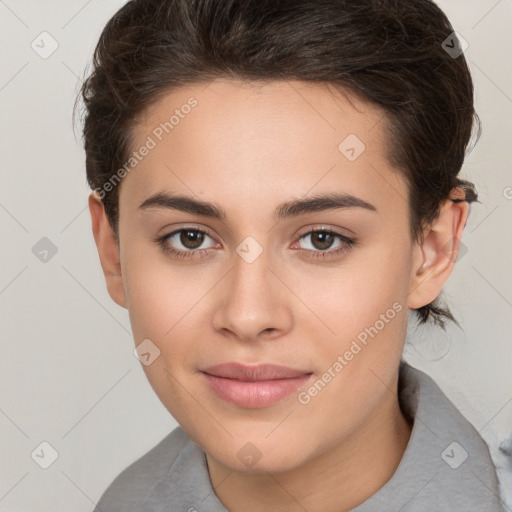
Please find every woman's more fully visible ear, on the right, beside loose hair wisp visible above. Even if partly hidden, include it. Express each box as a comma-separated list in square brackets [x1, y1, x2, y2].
[407, 187, 469, 309]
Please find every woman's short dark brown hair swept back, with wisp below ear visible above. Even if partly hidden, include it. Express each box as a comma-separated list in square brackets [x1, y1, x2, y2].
[75, 0, 480, 328]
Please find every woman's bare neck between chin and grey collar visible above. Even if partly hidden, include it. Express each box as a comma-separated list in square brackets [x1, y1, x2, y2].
[206, 380, 412, 512]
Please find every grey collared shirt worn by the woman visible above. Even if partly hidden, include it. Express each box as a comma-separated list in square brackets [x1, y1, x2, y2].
[94, 361, 504, 512]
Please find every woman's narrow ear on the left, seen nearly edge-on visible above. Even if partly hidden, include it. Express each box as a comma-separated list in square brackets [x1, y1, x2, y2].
[89, 192, 126, 308]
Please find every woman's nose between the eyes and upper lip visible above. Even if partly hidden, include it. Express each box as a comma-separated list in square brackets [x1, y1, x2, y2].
[213, 244, 293, 342]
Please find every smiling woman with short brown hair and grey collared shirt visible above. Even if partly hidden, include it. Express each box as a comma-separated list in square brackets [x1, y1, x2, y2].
[78, 0, 503, 512]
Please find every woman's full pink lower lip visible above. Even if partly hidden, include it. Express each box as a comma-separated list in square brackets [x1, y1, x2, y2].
[199, 373, 313, 408]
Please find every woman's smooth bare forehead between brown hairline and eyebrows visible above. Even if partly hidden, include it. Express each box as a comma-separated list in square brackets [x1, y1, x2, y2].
[121, 79, 407, 222]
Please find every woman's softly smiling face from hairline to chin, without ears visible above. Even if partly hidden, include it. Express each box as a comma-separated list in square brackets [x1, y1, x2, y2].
[92, 80, 424, 471]
